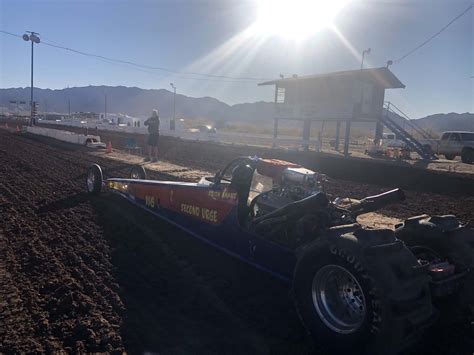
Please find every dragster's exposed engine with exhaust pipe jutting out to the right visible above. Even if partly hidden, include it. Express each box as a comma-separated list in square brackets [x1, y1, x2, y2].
[249, 163, 404, 248]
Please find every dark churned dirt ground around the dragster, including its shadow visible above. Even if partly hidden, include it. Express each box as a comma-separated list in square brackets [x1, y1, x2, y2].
[0, 130, 474, 354]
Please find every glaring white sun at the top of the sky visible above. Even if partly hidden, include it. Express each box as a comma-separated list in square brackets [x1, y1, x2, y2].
[253, 0, 350, 40]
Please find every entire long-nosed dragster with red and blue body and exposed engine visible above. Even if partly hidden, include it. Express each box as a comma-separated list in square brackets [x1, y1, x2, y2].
[87, 157, 474, 354]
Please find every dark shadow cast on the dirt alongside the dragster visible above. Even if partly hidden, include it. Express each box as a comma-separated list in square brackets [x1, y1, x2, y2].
[91, 196, 320, 354]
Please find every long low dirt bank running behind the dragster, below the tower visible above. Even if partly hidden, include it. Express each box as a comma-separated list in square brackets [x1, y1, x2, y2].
[41, 124, 474, 196]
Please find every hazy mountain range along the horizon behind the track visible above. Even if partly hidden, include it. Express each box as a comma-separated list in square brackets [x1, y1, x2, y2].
[0, 86, 474, 133]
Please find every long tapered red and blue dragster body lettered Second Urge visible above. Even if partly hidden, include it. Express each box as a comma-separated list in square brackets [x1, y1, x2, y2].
[106, 178, 296, 282]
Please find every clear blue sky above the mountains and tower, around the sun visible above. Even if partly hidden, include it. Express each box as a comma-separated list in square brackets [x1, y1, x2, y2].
[0, 0, 474, 118]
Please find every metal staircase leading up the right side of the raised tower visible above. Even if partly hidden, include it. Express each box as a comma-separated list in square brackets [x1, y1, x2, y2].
[381, 102, 437, 160]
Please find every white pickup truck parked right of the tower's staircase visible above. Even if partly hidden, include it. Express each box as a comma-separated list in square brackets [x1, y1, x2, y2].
[421, 131, 474, 164]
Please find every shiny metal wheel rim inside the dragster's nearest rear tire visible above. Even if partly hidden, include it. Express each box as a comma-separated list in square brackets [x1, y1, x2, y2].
[311, 264, 367, 334]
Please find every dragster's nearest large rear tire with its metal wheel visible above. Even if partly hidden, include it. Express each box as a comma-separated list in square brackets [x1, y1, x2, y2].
[293, 229, 432, 354]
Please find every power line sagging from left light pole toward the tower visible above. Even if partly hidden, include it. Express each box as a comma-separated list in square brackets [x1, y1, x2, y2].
[0, 30, 270, 82]
